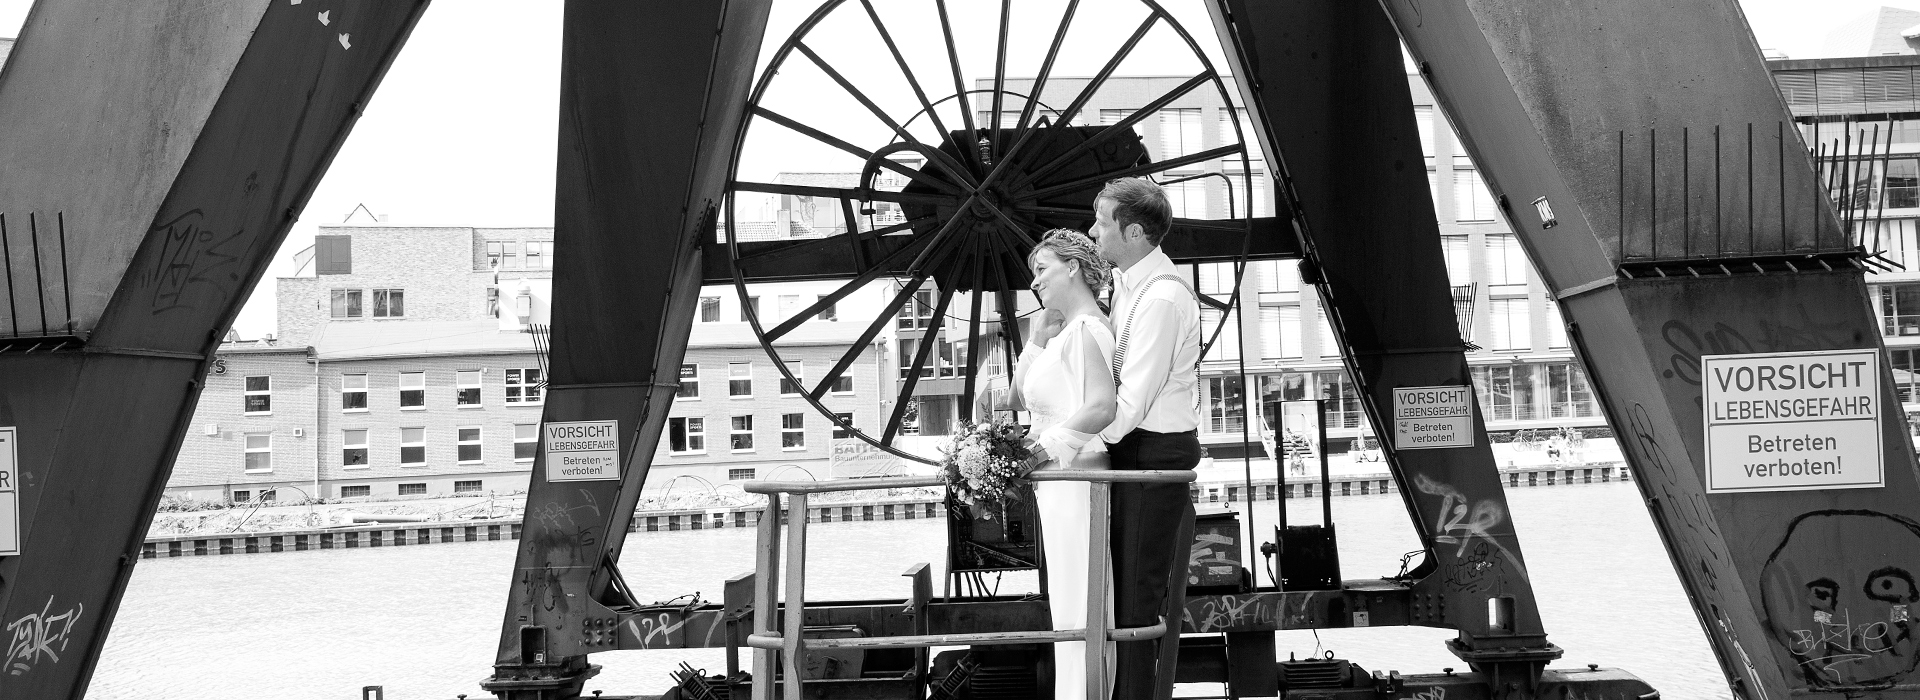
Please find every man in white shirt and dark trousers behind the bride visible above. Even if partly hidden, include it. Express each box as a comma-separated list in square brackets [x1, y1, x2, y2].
[1092, 178, 1200, 700]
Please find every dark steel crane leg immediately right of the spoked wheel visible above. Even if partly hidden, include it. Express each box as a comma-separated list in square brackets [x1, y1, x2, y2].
[1208, 0, 1559, 687]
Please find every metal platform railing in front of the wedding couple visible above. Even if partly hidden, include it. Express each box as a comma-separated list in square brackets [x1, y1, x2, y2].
[743, 470, 1194, 700]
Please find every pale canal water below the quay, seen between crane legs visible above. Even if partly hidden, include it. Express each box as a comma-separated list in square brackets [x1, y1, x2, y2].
[88, 481, 1730, 700]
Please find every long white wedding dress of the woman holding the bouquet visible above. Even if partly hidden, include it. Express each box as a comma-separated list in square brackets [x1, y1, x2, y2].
[1020, 316, 1114, 700]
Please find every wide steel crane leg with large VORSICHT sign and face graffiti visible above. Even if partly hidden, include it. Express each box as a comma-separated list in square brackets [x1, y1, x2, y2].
[1382, 0, 1920, 700]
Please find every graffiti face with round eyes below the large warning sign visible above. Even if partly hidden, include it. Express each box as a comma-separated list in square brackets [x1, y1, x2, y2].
[1761, 510, 1920, 690]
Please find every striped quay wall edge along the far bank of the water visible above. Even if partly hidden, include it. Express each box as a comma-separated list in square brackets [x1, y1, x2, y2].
[140, 462, 1628, 558]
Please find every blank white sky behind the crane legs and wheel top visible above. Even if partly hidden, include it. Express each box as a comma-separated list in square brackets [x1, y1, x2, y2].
[0, 0, 1920, 338]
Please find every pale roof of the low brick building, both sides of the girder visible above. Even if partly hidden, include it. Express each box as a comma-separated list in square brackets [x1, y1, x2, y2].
[307, 320, 864, 361]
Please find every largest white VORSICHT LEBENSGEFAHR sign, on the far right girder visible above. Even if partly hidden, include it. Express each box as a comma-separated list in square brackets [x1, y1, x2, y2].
[1699, 349, 1885, 493]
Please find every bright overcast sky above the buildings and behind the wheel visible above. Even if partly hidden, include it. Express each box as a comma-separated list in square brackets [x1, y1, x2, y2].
[0, 0, 1920, 338]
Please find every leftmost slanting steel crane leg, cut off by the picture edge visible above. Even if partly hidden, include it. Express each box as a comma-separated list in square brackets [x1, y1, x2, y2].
[0, 0, 426, 698]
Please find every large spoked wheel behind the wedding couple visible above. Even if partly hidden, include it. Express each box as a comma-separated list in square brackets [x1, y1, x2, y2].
[720, 0, 1256, 462]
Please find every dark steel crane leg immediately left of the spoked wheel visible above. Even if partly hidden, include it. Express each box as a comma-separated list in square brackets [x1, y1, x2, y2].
[484, 0, 770, 700]
